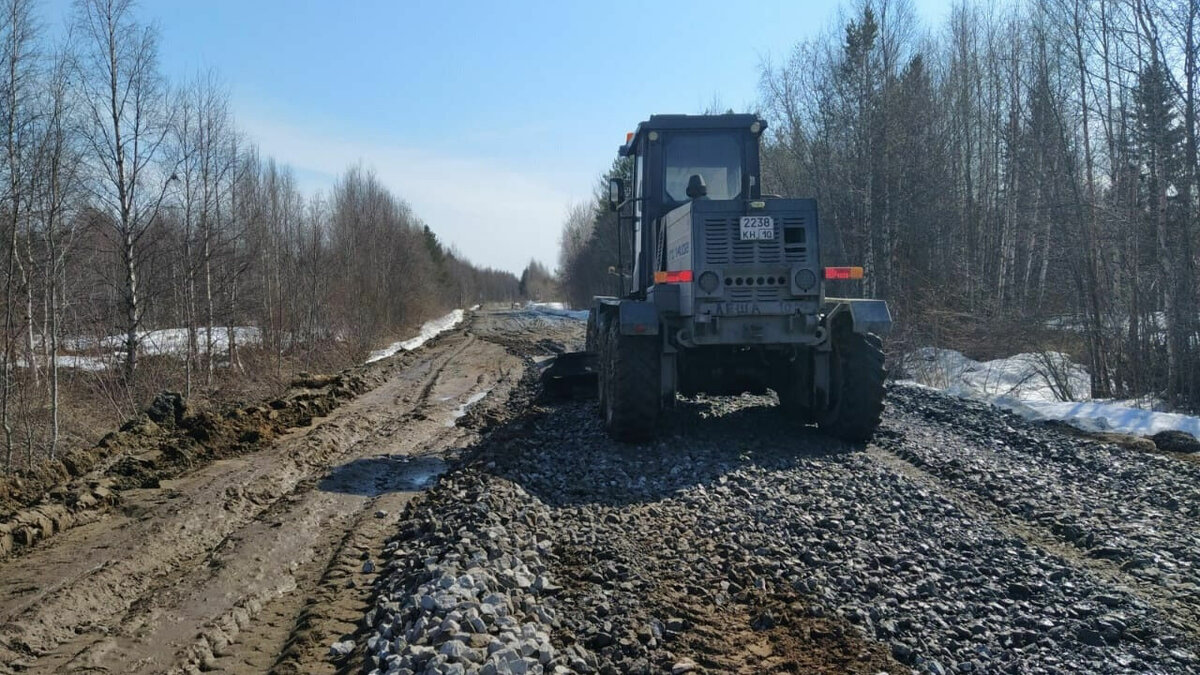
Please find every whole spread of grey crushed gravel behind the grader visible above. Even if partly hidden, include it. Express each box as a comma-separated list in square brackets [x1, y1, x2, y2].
[358, 388, 1200, 673]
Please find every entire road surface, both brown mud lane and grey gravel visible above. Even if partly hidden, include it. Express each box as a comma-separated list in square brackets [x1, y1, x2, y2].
[0, 311, 1200, 674]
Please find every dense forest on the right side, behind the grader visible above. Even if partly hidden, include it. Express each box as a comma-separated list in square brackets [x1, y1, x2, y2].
[559, 0, 1200, 411]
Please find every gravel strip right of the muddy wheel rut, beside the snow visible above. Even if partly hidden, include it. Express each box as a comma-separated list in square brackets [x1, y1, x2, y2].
[882, 389, 1200, 629]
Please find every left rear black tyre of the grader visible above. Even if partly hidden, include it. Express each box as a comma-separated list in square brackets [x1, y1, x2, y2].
[600, 321, 662, 443]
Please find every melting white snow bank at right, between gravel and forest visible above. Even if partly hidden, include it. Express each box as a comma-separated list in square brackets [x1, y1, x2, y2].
[901, 347, 1200, 438]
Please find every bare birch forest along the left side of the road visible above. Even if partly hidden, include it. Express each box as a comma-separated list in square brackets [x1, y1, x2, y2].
[0, 0, 520, 470]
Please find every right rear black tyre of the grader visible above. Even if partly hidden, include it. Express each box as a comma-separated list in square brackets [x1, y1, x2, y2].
[817, 330, 888, 443]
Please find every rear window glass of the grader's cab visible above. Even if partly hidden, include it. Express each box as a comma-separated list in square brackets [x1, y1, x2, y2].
[665, 133, 742, 202]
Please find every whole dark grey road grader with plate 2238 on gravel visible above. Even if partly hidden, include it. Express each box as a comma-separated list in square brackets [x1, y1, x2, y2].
[549, 114, 892, 441]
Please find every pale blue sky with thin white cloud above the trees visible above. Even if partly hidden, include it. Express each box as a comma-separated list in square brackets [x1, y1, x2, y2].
[43, 0, 946, 271]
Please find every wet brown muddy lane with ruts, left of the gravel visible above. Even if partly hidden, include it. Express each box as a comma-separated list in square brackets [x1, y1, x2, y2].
[0, 307, 572, 673]
